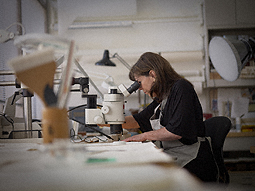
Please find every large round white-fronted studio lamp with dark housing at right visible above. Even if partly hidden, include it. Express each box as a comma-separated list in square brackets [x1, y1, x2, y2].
[209, 36, 255, 81]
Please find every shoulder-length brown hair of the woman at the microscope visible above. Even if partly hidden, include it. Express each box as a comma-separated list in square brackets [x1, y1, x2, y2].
[129, 52, 186, 101]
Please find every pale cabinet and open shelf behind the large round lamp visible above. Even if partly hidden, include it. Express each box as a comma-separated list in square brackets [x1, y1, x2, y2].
[204, 0, 255, 87]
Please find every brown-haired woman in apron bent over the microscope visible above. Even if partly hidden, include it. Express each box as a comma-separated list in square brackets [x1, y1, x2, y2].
[123, 52, 217, 181]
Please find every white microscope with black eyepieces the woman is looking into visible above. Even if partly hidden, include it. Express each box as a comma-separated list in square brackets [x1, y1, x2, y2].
[74, 77, 140, 139]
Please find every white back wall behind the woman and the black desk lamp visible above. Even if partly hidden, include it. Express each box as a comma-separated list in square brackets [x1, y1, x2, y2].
[55, 0, 205, 112]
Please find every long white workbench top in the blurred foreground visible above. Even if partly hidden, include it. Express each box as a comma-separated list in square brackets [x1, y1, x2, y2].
[0, 139, 204, 191]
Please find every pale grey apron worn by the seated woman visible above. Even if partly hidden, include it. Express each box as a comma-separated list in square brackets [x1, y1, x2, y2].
[150, 99, 202, 167]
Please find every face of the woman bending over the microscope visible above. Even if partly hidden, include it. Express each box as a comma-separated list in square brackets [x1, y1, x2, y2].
[135, 72, 155, 95]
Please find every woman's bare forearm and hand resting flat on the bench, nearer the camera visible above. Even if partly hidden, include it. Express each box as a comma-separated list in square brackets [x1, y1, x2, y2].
[123, 127, 182, 142]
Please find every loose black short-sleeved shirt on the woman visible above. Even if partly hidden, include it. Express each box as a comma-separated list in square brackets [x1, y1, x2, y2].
[133, 79, 205, 144]
